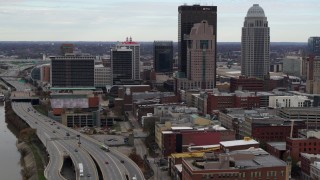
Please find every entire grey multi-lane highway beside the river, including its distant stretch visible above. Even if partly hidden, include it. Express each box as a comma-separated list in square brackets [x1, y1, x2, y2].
[3, 64, 144, 180]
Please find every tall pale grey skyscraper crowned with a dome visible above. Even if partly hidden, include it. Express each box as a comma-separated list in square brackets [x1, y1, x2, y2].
[241, 4, 270, 78]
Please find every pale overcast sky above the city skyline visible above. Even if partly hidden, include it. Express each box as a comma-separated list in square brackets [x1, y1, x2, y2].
[0, 0, 320, 42]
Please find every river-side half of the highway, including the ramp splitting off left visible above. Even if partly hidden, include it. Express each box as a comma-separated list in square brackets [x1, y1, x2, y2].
[12, 102, 99, 180]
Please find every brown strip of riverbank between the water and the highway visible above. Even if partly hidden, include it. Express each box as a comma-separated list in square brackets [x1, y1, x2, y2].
[5, 102, 49, 180]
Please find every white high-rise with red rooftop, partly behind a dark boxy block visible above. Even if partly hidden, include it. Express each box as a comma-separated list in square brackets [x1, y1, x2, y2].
[116, 37, 140, 80]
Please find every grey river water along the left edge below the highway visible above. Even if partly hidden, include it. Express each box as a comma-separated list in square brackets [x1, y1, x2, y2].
[0, 102, 22, 180]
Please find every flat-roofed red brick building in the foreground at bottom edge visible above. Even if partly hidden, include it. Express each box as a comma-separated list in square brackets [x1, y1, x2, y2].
[182, 148, 289, 180]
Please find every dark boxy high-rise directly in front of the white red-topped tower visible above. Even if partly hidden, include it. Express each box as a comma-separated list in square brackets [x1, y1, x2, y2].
[111, 47, 134, 84]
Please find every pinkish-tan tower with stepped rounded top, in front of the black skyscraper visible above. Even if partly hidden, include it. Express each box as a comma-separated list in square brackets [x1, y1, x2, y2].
[177, 20, 216, 90]
